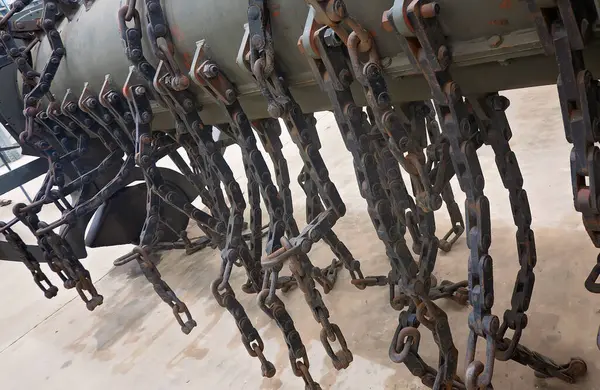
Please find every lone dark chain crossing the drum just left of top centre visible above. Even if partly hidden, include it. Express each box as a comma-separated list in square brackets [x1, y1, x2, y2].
[244, 0, 383, 291]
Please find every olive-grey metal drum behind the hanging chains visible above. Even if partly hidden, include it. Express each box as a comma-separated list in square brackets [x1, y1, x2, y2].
[35, 0, 598, 129]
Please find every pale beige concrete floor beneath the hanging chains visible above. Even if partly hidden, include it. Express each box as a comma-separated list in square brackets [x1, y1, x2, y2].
[0, 86, 600, 390]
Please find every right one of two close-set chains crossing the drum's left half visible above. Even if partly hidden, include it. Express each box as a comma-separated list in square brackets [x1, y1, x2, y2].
[119, 1, 290, 376]
